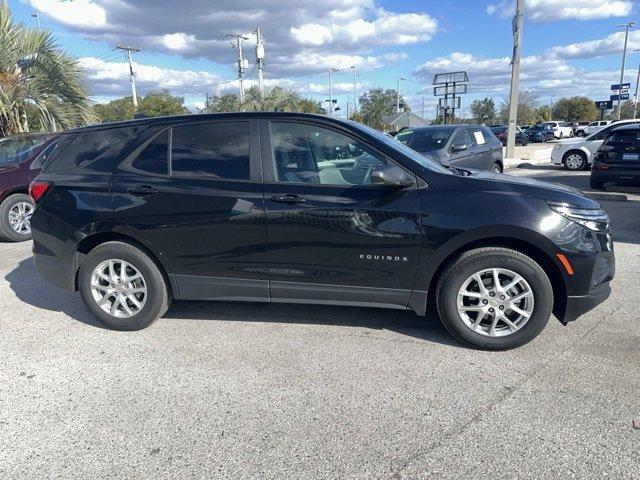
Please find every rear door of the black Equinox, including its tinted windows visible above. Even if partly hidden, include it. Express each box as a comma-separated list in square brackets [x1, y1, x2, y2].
[111, 120, 268, 301]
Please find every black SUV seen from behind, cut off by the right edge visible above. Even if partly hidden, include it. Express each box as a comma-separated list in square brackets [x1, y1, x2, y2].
[590, 124, 640, 190]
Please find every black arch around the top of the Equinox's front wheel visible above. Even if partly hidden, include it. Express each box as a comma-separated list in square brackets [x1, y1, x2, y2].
[427, 235, 567, 323]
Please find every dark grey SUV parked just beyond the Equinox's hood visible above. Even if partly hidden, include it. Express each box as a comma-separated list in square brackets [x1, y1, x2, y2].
[396, 125, 504, 173]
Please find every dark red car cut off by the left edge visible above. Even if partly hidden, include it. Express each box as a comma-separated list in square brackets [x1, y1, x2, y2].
[0, 133, 58, 242]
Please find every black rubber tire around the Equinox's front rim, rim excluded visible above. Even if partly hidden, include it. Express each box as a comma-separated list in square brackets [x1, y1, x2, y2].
[435, 247, 553, 350]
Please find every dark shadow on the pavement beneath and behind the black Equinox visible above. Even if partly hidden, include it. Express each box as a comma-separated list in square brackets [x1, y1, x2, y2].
[5, 258, 461, 347]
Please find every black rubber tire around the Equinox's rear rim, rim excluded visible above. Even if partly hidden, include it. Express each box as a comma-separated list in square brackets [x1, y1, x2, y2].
[78, 242, 171, 330]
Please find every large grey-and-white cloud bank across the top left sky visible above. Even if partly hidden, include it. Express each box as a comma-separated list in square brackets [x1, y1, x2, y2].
[23, 0, 437, 76]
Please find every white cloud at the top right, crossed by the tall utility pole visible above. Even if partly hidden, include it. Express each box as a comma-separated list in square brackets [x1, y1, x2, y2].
[487, 0, 633, 23]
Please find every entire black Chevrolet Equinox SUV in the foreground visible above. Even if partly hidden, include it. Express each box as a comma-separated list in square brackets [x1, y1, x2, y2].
[30, 113, 614, 349]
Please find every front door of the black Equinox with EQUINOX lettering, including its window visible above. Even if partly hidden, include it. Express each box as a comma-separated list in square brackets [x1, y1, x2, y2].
[261, 120, 420, 308]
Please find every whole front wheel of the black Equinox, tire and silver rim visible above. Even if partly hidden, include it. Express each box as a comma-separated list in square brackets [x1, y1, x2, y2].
[435, 247, 553, 350]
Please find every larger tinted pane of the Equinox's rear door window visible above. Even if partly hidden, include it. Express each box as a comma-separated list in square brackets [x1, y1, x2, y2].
[171, 122, 251, 180]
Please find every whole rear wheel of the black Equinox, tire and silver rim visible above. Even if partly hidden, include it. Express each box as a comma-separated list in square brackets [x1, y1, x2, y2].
[78, 242, 171, 330]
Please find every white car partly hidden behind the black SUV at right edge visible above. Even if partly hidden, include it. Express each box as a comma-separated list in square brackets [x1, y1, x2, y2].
[551, 119, 640, 170]
